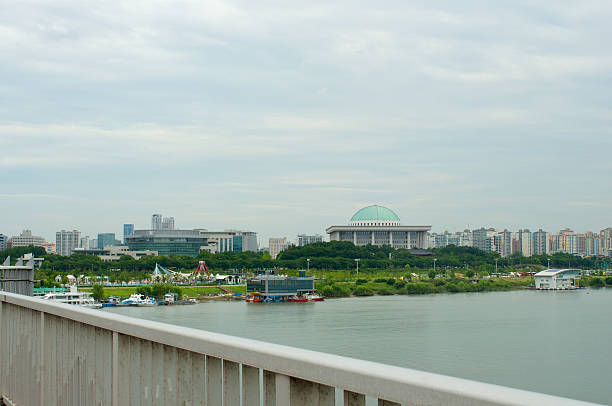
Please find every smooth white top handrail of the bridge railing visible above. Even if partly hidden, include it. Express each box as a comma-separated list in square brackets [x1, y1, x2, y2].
[0, 292, 594, 406]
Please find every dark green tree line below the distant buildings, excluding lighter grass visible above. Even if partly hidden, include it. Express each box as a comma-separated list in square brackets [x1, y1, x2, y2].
[0, 241, 612, 278]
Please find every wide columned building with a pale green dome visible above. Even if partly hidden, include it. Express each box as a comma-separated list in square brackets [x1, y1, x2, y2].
[325, 205, 431, 249]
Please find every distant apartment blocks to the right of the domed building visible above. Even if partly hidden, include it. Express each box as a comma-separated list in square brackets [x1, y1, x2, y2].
[428, 227, 612, 257]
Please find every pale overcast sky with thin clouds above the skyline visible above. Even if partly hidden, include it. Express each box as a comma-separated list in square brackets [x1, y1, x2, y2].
[0, 0, 612, 246]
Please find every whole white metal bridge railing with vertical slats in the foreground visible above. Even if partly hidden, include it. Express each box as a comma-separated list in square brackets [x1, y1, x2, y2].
[0, 292, 604, 406]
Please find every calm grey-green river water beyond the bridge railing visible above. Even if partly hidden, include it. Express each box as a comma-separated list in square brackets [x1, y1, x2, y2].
[107, 289, 612, 404]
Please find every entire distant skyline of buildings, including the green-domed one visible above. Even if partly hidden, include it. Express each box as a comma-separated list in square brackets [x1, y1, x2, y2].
[0, 205, 612, 261]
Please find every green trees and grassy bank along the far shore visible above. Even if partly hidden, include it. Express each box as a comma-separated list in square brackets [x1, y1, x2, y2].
[0, 241, 612, 297]
